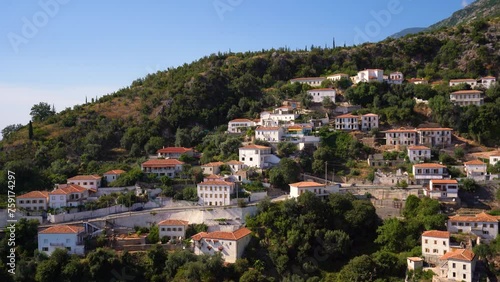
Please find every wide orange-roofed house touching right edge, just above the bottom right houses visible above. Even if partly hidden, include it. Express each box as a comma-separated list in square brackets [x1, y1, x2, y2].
[447, 212, 499, 241]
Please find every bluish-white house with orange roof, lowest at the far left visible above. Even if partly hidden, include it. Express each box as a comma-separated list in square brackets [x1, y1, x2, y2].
[38, 225, 85, 255]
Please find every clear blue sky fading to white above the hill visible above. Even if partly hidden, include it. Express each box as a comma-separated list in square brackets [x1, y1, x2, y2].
[0, 0, 471, 137]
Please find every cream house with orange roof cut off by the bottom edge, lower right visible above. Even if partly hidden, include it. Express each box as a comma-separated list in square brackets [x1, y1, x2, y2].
[438, 249, 477, 282]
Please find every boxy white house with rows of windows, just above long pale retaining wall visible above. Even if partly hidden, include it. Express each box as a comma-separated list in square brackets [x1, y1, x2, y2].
[197, 177, 235, 206]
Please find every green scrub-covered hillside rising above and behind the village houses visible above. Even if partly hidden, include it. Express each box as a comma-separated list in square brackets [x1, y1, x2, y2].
[0, 19, 500, 192]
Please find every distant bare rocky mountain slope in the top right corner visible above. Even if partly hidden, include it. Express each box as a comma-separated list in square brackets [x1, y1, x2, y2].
[429, 0, 500, 30]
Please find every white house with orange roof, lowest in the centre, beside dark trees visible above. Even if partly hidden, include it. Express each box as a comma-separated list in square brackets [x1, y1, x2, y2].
[191, 227, 252, 263]
